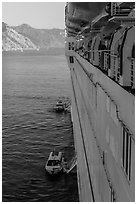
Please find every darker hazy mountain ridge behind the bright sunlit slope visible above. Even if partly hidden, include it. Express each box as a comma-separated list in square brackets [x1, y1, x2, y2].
[13, 24, 65, 49]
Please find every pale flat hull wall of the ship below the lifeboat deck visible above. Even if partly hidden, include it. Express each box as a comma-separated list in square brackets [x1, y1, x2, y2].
[66, 50, 135, 202]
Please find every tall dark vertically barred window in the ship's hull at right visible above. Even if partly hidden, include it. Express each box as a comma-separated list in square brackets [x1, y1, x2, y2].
[122, 126, 132, 181]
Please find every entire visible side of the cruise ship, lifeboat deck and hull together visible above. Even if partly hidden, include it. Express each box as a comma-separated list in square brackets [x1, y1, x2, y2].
[65, 2, 135, 202]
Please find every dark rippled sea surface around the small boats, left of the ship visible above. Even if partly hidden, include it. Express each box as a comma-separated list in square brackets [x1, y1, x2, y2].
[2, 54, 78, 202]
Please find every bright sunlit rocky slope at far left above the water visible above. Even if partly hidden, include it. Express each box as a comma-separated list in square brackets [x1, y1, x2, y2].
[2, 23, 38, 51]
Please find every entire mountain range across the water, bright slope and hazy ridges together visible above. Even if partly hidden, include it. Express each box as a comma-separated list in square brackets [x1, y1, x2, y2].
[2, 22, 65, 51]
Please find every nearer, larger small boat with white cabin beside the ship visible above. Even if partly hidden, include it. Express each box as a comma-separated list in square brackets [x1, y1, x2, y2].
[45, 151, 64, 175]
